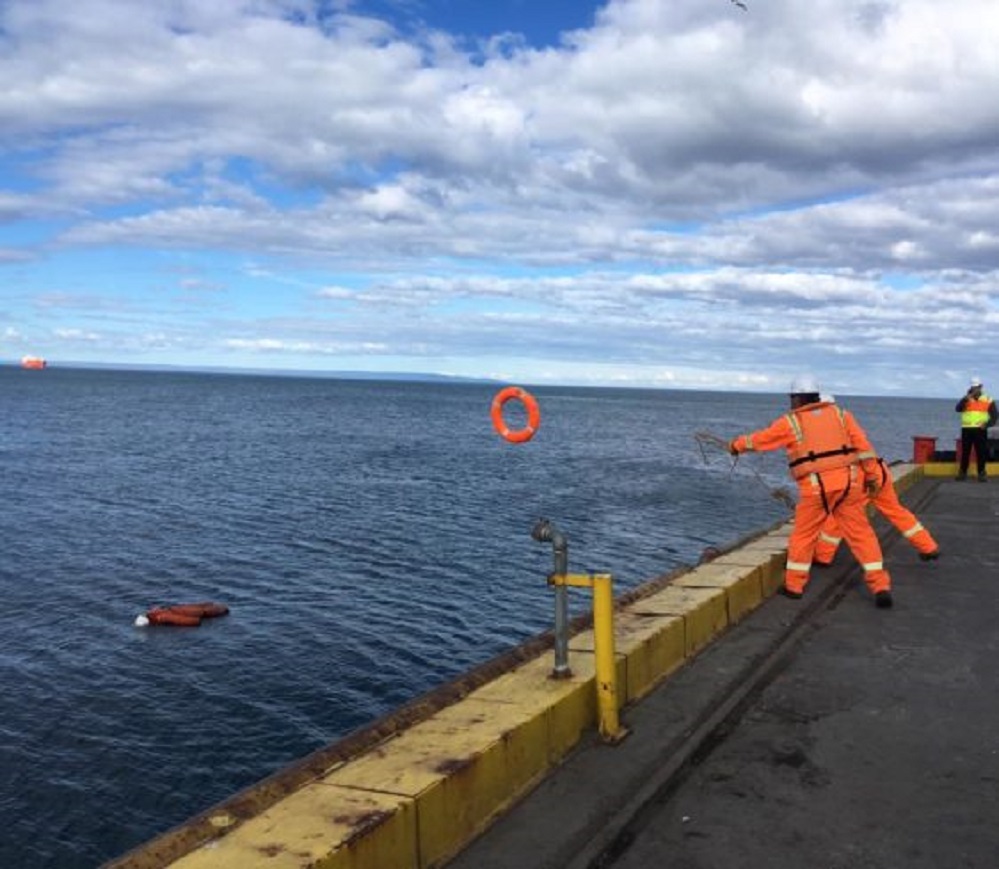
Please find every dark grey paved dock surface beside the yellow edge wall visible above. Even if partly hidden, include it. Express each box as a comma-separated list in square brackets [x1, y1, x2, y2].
[447, 478, 999, 869]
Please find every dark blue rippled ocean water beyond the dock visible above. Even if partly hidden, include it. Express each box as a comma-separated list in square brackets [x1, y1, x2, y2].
[0, 366, 957, 869]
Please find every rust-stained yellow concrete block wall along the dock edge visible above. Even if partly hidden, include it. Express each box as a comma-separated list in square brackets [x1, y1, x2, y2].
[107, 463, 925, 869]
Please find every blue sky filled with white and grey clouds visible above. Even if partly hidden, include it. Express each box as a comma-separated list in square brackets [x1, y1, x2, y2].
[0, 0, 999, 397]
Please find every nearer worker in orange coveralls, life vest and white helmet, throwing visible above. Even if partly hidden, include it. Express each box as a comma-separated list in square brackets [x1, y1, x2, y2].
[729, 375, 892, 608]
